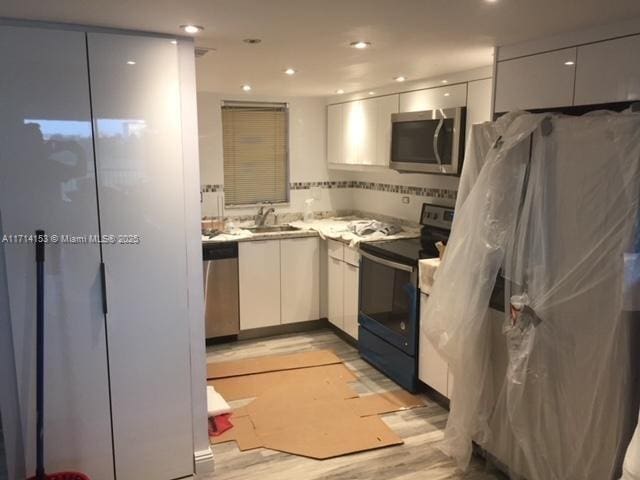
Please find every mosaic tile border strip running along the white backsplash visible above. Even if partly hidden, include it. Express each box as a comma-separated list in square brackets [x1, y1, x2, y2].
[201, 180, 458, 200]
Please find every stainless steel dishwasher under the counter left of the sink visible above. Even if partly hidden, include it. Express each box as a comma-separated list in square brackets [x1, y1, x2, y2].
[202, 242, 240, 338]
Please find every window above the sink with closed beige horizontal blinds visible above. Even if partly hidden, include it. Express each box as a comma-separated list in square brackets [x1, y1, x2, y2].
[222, 102, 289, 205]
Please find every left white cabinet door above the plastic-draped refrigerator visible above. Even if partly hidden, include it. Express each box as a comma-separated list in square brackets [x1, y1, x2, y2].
[495, 48, 576, 112]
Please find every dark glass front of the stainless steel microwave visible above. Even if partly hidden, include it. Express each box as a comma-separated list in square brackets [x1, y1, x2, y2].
[391, 118, 454, 165]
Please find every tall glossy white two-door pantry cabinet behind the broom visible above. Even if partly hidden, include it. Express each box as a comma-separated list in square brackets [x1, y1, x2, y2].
[0, 24, 206, 480]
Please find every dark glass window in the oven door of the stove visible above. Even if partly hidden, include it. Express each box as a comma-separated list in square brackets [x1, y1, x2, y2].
[360, 257, 417, 338]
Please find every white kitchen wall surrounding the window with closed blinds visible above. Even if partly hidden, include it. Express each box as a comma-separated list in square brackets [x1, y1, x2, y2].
[198, 92, 351, 216]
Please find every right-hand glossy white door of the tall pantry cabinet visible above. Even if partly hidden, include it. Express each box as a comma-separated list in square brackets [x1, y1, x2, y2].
[88, 33, 193, 479]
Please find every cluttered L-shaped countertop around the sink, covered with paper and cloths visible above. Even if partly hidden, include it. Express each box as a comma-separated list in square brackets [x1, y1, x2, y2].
[202, 217, 420, 247]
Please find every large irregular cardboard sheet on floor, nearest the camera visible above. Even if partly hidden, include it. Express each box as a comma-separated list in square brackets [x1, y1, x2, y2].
[209, 354, 424, 459]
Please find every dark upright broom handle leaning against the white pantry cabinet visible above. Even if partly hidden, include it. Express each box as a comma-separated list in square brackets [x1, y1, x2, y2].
[36, 230, 45, 480]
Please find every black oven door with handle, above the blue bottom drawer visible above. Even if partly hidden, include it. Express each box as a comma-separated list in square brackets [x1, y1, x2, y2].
[358, 251, 420, 356]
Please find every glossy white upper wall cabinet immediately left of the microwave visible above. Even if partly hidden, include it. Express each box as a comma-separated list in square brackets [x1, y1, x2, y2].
[327, 95, 398, 166]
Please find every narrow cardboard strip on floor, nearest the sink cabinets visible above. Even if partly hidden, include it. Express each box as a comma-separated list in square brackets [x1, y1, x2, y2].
[207, 350, 342, 380]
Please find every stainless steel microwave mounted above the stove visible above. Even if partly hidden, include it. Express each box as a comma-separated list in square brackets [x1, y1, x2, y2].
[390, 107, 467, 175]
